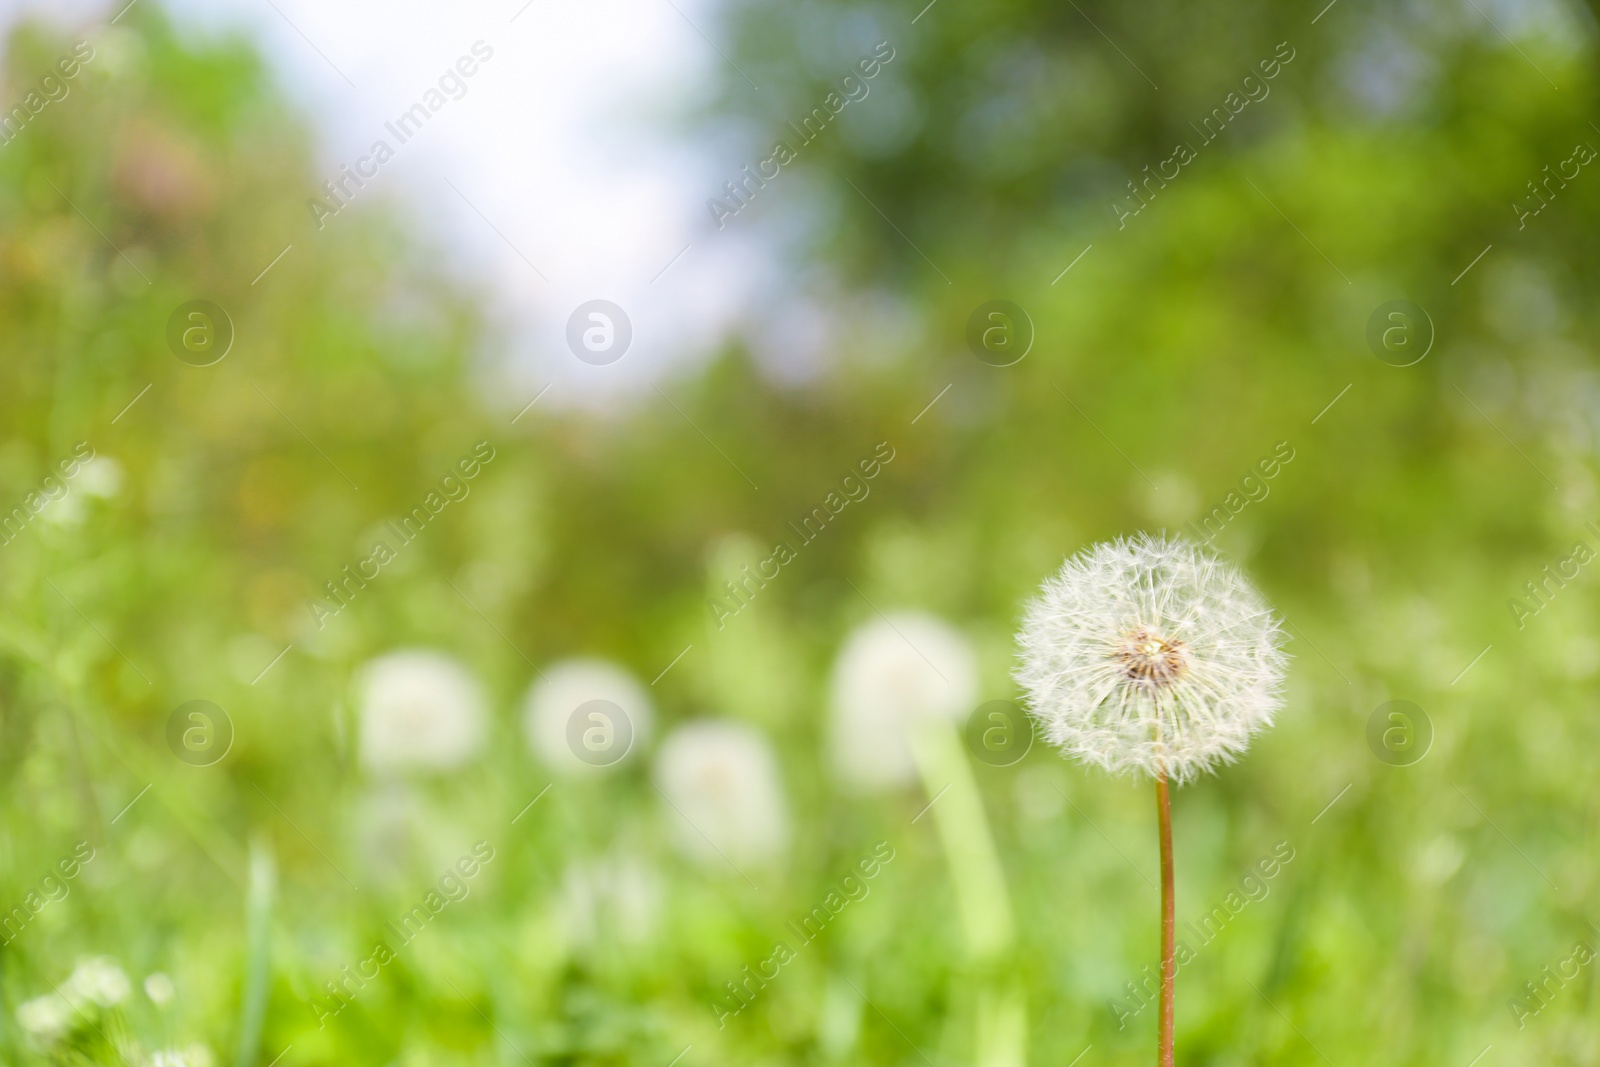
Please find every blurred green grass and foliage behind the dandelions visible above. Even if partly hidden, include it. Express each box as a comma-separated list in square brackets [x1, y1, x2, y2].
[0, 0, 1600, 1067]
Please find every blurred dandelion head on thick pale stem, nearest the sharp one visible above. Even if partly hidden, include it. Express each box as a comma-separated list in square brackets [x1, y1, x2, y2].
[830, 613, 978, 789]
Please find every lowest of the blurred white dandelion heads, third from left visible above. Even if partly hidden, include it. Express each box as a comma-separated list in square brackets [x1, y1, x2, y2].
[656, 720, 789, 867]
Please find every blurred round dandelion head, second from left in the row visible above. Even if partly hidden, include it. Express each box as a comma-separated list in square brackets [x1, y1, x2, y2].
[522, 659, 654, 774]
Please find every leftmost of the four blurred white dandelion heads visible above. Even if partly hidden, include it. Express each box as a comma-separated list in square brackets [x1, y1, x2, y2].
[360, 649, 485, 773]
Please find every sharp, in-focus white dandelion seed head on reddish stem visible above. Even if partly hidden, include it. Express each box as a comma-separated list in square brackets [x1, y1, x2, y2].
[1016, 534, 1288, 782]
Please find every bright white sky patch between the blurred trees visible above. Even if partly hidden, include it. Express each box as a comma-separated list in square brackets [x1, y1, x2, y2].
[0, 0, 771, 403]
